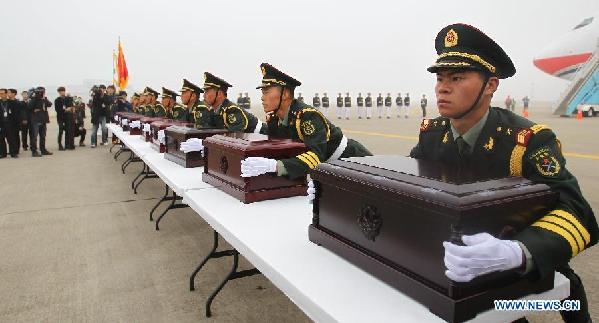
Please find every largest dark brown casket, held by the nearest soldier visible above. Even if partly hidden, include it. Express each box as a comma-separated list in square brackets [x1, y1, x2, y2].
[309, 156, 557, 322]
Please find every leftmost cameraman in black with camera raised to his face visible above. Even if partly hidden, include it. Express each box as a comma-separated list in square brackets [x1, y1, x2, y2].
[27, 86, 52, 157]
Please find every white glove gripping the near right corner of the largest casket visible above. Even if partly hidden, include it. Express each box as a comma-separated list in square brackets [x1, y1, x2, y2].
[443, 232, 522, 282]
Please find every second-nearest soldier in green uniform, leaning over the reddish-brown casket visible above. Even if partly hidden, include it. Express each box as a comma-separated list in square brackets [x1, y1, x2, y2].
[241, 63, 371, 179]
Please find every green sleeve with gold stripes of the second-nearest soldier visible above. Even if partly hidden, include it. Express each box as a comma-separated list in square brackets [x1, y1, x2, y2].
[281, 111, 330, 179]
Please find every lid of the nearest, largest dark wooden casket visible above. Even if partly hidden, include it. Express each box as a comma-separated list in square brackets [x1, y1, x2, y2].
[313, 155, 549, 207]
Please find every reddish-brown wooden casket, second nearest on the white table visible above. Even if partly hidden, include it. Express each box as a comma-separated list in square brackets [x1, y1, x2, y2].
[202, 133, 308, 203]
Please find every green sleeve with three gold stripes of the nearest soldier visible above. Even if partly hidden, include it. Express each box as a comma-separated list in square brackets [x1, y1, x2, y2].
[516, 129, 599, 277]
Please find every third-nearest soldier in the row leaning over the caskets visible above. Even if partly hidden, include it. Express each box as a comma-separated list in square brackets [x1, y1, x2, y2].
[204, 72, 262, 133]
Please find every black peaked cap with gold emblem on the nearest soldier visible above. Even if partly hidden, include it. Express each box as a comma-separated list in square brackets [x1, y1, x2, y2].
[427, 24, 516, 79]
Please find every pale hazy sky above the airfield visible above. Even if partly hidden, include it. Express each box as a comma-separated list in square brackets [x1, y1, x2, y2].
[0, 0, 599, 100]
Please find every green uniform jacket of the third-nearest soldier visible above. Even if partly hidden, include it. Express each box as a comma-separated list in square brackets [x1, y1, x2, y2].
[210, 99, 262, 132]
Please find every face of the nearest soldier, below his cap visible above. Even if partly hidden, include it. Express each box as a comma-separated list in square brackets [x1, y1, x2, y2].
[436, 70, 497, 118]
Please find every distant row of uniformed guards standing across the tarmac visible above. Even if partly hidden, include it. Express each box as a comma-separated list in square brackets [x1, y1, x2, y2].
[290, 93, 428, 120]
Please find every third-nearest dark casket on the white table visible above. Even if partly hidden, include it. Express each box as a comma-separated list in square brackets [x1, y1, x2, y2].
[164, 126, 228, 168]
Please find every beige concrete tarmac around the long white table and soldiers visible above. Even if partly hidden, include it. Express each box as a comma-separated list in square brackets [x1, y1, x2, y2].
[0, 106, 599, 322]
